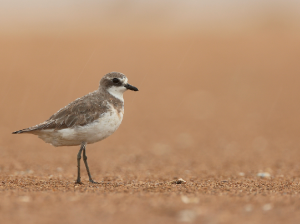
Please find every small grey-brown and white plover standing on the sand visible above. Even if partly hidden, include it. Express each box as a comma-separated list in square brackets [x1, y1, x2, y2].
[13, 72, 138, 184]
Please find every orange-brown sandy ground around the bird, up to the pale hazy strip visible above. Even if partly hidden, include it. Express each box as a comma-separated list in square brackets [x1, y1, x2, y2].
[0, 32, 300, 224]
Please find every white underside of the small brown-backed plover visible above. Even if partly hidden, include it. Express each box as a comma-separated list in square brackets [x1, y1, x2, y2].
[34, 105, 124, 146]
